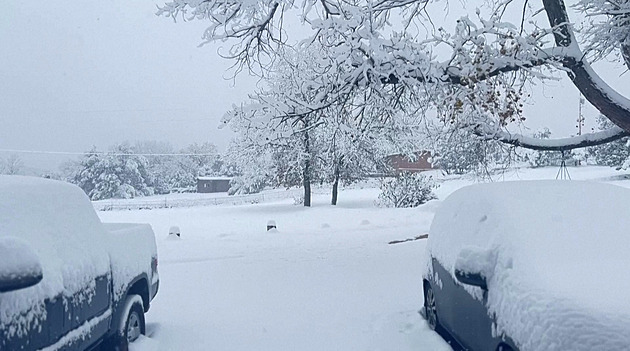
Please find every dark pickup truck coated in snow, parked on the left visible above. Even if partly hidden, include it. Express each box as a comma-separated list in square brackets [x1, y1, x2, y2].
[0, 176, 159, 351]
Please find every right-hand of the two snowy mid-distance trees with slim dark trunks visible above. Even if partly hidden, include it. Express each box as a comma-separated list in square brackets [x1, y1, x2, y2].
[319, 89, 422, 205]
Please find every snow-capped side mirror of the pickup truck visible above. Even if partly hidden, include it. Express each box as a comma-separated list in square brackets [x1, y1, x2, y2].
[0, 236, 43, 293]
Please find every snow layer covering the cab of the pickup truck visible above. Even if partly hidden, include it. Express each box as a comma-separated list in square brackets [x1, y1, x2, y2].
[0, 176, 109, 333]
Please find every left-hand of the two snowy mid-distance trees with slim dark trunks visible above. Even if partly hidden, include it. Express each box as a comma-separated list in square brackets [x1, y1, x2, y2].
[223, 46, 338, 206]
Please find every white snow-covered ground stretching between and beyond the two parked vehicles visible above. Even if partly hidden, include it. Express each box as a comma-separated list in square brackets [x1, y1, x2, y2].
[99, 167, 630, 351]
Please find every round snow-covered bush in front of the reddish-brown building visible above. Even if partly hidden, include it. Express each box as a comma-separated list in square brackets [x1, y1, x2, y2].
[376, 173, 437, 207]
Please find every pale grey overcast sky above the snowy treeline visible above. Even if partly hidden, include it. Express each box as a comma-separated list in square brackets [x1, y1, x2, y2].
[0, 0, 630, 173]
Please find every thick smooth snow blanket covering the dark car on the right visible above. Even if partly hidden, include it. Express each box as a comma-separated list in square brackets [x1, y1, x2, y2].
[427, 181, 630, 350]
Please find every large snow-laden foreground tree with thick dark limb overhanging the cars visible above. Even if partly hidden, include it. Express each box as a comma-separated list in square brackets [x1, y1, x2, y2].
[158, 0, 630, 151]
